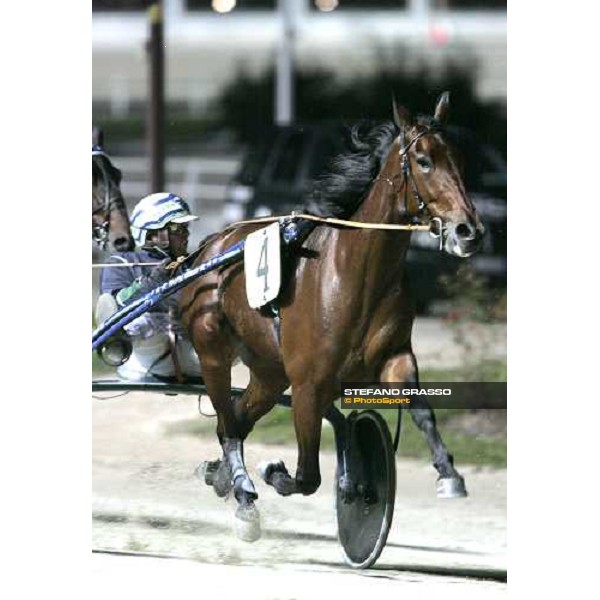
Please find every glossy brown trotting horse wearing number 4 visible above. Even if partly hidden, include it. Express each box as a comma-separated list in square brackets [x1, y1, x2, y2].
[180, 93, 484, 539]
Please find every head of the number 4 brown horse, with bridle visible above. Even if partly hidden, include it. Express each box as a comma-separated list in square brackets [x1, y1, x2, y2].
[392, 92, 485, 257]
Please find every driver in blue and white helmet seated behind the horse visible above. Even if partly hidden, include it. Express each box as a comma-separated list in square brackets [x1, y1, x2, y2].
[96, 192, 200, 381]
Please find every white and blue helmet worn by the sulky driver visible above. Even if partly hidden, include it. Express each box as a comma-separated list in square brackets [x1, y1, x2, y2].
[131, 192, 198, 246]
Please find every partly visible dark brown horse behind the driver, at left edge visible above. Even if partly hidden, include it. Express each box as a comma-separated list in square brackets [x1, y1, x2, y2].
[92, 127, 134, 252]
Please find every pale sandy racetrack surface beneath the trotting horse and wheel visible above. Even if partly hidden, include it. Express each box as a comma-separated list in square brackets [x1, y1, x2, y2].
[92, 364, 506, 599]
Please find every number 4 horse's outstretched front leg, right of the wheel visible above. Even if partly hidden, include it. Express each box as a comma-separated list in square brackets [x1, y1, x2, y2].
[380, 352, 467, 498]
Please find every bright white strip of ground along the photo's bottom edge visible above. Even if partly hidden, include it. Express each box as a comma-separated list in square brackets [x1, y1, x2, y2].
[92, 554, 506, 600]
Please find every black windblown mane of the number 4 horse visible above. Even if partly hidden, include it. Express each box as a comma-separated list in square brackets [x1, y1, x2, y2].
[306, 122, 398, 218]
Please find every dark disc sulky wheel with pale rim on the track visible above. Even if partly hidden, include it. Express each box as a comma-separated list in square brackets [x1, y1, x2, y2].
[336, 410, 396, 569]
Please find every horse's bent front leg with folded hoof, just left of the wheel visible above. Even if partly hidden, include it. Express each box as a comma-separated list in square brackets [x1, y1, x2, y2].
[259, 384, 328, 496]
